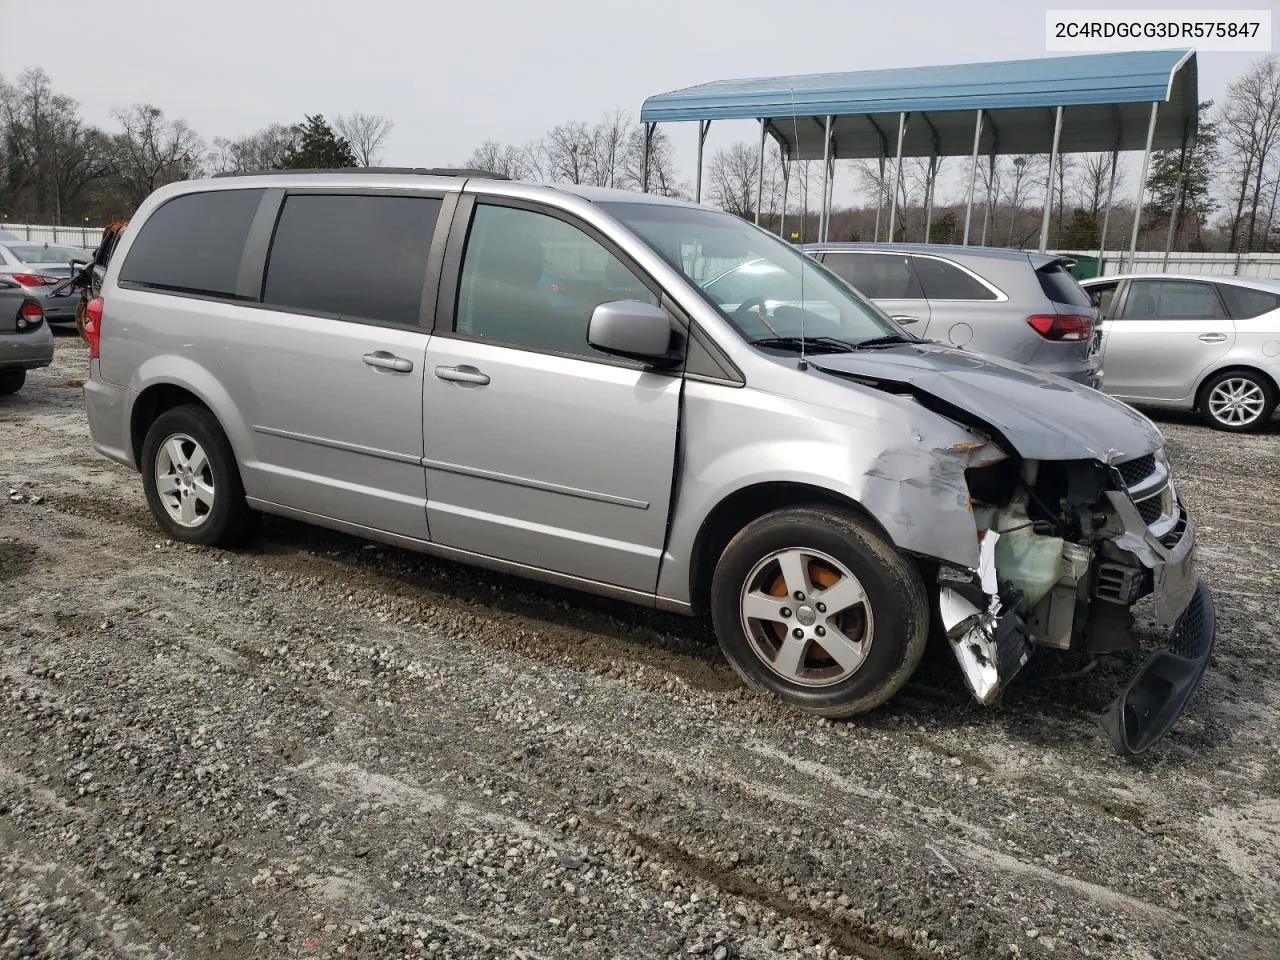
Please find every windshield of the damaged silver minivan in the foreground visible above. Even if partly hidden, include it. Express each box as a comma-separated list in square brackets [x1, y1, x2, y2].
[602, 202, 908, 348]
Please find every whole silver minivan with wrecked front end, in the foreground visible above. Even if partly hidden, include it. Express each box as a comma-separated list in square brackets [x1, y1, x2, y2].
[84, 172, 1213, 753]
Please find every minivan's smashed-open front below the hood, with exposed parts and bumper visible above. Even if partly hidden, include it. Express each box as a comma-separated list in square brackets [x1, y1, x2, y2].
[938, 448, 1213, 755]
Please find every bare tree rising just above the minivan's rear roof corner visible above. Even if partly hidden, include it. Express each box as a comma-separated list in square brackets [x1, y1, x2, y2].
[108, 104, 205, 206]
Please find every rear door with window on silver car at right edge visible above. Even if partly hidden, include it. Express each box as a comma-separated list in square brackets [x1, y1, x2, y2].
[1102, 279, 1235, 403]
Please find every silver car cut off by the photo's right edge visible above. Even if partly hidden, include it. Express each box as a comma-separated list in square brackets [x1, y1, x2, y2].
[1083, 274, 1280, 433]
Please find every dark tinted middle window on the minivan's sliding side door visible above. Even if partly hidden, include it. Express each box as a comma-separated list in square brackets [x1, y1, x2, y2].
[262, 193, 440, 326]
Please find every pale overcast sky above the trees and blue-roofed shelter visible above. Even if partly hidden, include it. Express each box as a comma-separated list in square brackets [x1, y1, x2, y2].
[0, 0, 1264, 208]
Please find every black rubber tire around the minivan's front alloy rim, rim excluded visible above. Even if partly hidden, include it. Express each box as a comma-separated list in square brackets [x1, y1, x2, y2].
[710, 506, 929, 717]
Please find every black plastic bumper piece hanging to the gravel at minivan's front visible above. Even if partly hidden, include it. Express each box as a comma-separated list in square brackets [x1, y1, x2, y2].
[1100, 582, 1217, 756]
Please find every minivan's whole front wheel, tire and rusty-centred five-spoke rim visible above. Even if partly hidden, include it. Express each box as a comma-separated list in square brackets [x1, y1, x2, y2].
[712, 507, 929, 717]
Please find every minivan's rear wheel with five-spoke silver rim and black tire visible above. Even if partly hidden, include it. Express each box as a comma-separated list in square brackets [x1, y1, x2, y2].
[142, 404, 256, 547]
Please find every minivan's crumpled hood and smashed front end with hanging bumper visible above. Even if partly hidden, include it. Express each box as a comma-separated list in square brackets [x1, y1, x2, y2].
[817, 343, 1215, 755]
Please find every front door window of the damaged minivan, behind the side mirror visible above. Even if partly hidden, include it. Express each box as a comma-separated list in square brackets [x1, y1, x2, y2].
[454, 204, 658, 360]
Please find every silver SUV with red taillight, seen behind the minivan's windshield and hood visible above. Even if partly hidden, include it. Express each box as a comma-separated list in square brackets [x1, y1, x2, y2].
[805, 243, 1101, 387]
